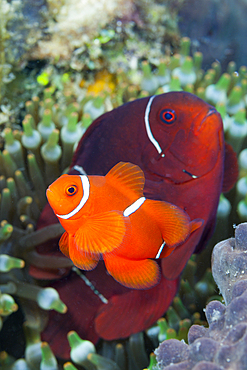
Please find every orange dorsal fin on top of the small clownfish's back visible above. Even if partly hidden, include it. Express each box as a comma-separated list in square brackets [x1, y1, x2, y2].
[106, 162, 145, 197]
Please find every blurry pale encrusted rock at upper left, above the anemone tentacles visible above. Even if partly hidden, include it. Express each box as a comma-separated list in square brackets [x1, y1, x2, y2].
[0, 0, 179, 124]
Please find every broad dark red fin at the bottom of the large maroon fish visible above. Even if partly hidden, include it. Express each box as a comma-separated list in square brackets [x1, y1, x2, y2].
[94, 276, 179, 340]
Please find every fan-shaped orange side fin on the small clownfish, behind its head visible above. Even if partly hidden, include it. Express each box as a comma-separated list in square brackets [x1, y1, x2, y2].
[75, 212, 127, 254]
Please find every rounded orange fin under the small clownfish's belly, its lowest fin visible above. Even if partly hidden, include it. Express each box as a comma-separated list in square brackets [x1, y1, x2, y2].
[103, 253, 160, 289]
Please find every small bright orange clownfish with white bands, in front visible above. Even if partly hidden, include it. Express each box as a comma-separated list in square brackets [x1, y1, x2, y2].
[46, 162, 203, 289]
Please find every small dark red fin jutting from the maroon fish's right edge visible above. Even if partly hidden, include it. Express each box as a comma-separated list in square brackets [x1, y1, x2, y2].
[222, 142, 238, 193]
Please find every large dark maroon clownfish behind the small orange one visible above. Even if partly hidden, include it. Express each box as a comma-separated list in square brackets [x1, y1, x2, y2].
[33, 92, 238, 358]
